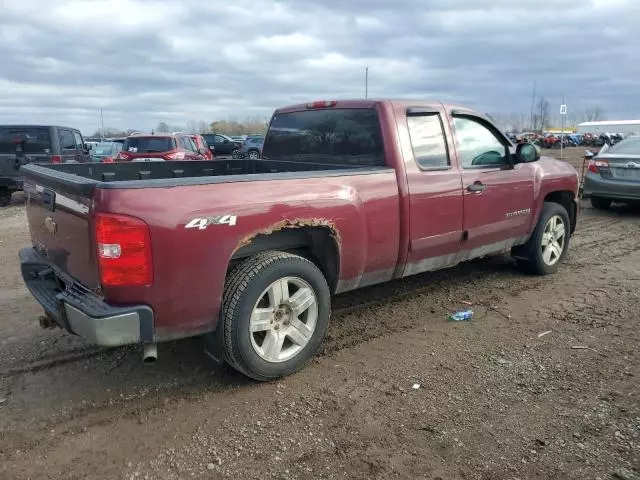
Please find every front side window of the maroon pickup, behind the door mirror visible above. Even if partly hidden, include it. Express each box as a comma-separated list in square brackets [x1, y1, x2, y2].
[453, 116, 509, 168]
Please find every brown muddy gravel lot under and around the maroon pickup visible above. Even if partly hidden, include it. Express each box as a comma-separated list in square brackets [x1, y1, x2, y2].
[0, 149, 640, 480]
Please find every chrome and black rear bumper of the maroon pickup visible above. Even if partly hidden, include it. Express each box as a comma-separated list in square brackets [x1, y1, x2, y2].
[20, 248, 154, 347]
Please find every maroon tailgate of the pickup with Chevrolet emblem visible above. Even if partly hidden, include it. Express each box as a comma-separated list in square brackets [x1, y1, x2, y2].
[24, 170, 99, 289]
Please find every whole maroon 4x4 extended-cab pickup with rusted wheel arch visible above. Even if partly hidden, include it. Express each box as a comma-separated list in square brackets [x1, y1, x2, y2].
[20, 100, 578, 380]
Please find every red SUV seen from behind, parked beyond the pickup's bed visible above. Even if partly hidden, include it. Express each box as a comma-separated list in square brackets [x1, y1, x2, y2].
[116, 133, 208, 162]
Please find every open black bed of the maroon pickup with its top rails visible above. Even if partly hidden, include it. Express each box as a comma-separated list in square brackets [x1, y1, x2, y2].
[22, 159, 387, 195]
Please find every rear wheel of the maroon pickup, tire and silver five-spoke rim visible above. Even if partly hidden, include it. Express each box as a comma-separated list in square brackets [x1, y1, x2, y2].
[222, 252, 331, 381]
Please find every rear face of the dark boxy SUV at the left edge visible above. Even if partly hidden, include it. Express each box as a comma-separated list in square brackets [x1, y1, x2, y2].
[0, 125, 52, 182]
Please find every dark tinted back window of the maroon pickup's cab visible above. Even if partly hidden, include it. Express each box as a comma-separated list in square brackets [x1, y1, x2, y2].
[263, 108, 384, 166]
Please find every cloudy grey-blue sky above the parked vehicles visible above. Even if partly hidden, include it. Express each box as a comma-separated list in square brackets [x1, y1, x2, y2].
[0, 0, 640, 134]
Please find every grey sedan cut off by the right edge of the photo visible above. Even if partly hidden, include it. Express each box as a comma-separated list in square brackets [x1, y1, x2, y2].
[583, 137, 640, 209]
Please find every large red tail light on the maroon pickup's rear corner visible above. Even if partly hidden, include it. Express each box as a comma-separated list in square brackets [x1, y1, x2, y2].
[95, 214, 153, 287]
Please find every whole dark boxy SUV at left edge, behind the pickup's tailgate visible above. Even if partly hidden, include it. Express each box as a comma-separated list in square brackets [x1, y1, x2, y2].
[0, 125, 90, 206]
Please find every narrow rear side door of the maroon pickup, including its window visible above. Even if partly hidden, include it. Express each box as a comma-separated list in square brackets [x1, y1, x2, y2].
[399, 108, 463, 275]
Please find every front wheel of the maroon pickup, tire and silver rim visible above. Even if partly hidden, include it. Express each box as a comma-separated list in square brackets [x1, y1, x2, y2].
[513, 202, 571, 275]
